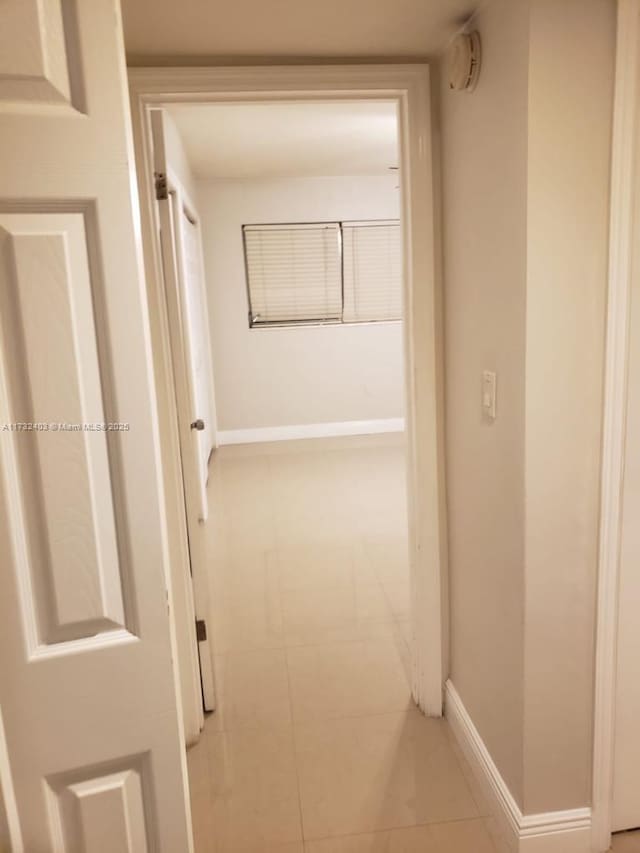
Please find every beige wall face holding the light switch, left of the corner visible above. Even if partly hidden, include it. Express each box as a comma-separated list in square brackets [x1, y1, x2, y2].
[440, 0, 529, 802]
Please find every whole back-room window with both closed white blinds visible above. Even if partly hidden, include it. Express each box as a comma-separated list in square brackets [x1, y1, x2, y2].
[242, 220, 402, 327]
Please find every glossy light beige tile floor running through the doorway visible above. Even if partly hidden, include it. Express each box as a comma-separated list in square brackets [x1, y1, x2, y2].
[188, 436, 508, 853]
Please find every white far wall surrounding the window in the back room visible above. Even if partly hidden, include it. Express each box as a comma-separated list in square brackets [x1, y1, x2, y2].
[197, 175, 404, 430]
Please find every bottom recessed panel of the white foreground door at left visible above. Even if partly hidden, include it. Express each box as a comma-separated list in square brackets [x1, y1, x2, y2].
[47, 756, 151, 853]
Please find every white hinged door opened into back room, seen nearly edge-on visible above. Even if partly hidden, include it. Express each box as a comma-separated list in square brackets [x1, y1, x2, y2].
[151, 110, 215, 711]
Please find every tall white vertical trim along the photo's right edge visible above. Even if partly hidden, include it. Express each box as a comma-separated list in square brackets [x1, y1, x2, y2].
[592, 0, 640, 853]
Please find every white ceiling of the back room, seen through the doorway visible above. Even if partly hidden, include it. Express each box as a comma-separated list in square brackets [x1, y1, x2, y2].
[162, 101, 398, 178]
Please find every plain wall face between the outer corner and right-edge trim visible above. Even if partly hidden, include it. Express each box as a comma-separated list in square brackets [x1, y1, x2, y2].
[524, 0, 616, 812]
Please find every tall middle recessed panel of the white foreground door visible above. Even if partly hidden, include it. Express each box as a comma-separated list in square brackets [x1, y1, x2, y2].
[0, 213, 127, 653]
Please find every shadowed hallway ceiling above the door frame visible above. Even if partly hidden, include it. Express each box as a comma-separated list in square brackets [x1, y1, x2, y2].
[122, 0, 475, 65]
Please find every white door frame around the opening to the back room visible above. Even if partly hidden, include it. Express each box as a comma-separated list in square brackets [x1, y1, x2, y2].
[129, 64, 448, 717]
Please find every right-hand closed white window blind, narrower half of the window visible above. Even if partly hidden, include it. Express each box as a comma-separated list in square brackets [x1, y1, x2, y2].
[342, 221, 402, 323]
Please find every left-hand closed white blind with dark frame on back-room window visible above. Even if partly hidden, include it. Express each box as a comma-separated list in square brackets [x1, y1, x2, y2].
[243, 223, 342, 326]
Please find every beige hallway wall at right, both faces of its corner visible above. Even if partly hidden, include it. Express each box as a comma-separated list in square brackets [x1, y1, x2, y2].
[440, 0, 615, 814]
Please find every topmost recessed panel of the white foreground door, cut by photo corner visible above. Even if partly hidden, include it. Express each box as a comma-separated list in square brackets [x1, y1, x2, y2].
[0, 0, 78, 108]
